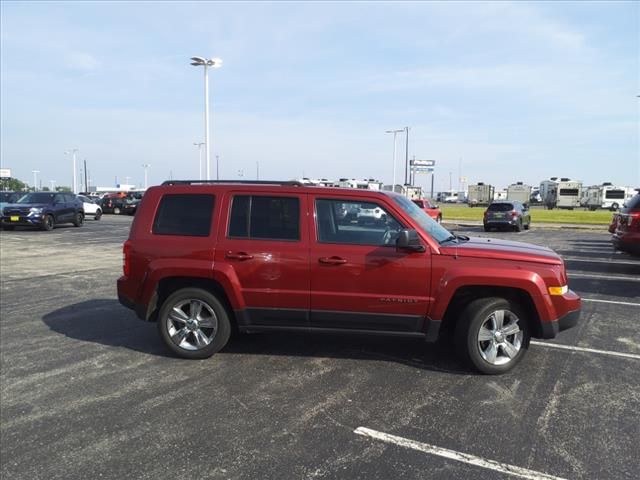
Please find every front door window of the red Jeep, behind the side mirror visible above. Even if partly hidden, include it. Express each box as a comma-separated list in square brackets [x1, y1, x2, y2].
[316, 199, 402, 246]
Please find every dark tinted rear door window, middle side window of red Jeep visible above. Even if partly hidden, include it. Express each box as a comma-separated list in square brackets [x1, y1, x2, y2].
[229, 195, 300, 240]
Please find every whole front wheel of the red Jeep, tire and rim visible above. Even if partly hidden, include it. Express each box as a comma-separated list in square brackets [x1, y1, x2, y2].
[456, 298, 530, 375]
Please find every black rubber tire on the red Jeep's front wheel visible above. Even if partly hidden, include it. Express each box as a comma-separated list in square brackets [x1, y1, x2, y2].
[455, 297, 531, 375]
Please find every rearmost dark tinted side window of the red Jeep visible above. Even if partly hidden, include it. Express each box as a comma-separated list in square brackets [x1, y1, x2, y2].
[153, 194, 214, 237]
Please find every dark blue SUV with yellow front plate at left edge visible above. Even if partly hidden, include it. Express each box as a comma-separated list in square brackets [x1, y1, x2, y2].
[0, 192, 84, 230]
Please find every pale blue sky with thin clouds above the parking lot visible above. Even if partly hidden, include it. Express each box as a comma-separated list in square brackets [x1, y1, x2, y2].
[1, 1, 640, 190]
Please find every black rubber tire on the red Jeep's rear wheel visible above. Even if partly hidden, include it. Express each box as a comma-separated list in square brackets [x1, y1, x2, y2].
[158, 288, 231, 359]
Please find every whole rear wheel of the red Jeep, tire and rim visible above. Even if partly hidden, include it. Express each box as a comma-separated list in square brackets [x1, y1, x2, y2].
[158, 288, 231, 359]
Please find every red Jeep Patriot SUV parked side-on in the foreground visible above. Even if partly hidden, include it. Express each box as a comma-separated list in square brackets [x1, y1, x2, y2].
[118, 181, 580, 374]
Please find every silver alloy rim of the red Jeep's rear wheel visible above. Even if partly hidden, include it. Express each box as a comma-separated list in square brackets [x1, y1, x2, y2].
[166, 298, 218, 351]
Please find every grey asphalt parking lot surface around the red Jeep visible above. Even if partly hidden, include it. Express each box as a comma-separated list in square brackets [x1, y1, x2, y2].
[0, 215, 640, 479]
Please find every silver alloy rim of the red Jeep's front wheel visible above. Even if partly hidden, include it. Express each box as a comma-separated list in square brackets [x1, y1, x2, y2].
[477, 310, 524, 365]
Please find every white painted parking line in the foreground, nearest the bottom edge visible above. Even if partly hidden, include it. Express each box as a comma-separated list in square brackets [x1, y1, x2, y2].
[353, 427, 562, 480]
